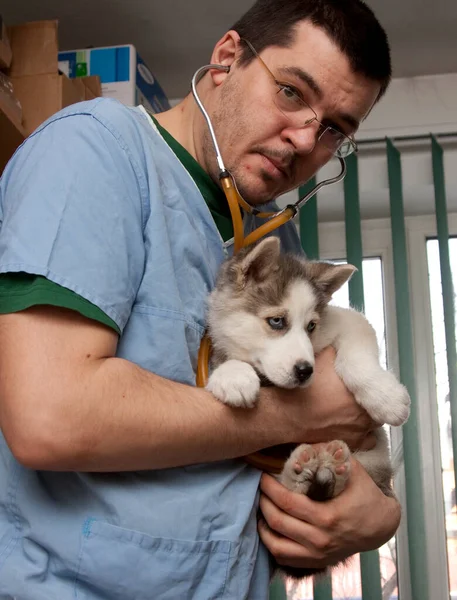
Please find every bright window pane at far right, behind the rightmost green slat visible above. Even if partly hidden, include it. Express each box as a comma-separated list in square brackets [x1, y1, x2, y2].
[427, 238, 457, 598]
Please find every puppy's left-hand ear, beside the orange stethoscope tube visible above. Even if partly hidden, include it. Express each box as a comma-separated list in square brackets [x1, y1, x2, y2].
[237, 237, 281, 287]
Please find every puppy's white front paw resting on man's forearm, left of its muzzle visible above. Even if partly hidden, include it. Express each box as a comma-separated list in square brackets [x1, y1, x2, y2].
[206, 360, 260, 408]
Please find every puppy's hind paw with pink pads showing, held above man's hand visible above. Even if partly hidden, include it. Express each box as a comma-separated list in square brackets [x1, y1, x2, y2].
[279, 440, 351, 500]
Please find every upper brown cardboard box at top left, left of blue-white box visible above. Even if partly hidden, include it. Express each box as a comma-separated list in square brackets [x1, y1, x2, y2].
[8, 21, 59, 77]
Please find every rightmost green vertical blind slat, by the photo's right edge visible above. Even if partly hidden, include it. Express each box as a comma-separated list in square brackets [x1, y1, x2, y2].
[432, 136, 457, 506]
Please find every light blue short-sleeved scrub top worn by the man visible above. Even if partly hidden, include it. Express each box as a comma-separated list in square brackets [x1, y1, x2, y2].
[0, 99, 300, 600]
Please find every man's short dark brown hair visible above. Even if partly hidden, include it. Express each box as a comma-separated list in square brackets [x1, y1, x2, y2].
[231, 0, 392, 100]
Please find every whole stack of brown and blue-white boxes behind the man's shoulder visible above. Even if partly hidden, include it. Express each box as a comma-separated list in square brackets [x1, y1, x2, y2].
[0, 16, 170, 175]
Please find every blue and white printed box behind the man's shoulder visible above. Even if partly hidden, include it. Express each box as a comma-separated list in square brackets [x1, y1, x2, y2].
[59, 45, 170, 112]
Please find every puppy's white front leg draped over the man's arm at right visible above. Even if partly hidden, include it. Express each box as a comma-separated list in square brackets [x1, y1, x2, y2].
[323, 306, 411, 425]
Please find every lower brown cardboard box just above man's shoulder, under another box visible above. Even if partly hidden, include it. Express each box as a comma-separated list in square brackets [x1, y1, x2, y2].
[12, 73, 85, 135]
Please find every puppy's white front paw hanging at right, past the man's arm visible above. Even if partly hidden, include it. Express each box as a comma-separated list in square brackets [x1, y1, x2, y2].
[355, 371, 411, 426]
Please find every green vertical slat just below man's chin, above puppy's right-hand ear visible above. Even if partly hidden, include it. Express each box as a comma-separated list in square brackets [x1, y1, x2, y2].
[298, 177, 333, 600]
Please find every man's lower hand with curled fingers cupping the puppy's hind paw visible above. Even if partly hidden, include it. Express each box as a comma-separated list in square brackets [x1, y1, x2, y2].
[259, 458, 401, 568]
